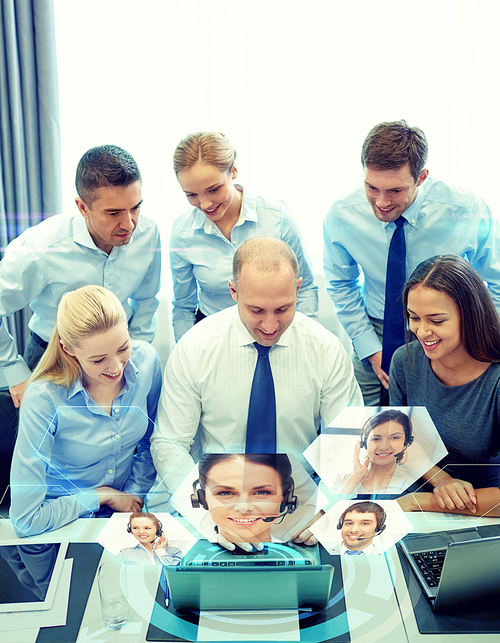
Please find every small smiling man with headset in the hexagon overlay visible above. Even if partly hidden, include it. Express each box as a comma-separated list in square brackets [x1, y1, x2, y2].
[331, 501, 387, 555]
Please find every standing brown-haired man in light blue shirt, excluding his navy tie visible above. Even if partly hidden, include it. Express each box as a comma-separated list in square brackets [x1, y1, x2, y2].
[323, 121, 500, 405]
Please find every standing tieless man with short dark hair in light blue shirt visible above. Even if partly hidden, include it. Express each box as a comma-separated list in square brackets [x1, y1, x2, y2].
[0, 145, 161, 406]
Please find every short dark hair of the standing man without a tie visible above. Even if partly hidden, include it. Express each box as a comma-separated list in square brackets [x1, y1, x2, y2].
[75, 145, 141, 206]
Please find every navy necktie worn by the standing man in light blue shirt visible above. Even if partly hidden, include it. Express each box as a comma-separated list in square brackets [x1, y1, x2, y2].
[382, 216, 406, 374]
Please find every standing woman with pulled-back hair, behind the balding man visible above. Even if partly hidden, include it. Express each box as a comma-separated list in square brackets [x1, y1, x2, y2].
[170, 132, 318, 341]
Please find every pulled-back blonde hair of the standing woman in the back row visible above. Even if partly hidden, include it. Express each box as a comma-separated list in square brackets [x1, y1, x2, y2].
[174, 132, 236, 174]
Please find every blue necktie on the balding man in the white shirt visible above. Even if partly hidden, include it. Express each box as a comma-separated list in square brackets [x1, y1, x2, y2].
[245, 342, 276, 453]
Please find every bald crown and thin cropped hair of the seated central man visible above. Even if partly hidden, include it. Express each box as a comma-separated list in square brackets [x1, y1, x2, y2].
[233, 237, 299, 288]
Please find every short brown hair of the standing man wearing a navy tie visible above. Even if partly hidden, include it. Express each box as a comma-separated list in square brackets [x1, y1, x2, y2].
[361, 120, 428, 183]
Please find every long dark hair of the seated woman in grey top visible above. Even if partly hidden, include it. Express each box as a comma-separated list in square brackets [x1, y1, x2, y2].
[403, 255, 500, 362]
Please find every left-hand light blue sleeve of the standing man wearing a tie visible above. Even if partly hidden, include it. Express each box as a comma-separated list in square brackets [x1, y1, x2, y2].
[323, 216, 382, 359]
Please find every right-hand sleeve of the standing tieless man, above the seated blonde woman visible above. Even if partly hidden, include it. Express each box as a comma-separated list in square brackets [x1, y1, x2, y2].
[129, 226, 161, 342]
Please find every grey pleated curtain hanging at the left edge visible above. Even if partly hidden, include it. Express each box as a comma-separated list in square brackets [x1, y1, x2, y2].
[0, 0, 61, 353]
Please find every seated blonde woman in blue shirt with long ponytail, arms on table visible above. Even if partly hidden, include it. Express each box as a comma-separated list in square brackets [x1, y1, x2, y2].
[10, 286, 161, 536]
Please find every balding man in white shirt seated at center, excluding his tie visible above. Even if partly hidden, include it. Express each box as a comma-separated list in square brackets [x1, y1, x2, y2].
[148, 237, 362, 506]
